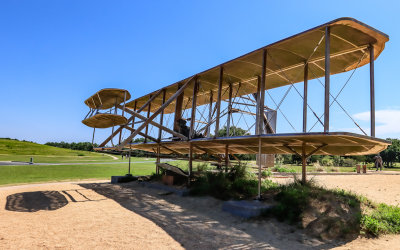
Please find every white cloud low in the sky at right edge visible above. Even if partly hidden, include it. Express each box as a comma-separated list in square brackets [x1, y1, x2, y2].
[353, 109, 400, 137]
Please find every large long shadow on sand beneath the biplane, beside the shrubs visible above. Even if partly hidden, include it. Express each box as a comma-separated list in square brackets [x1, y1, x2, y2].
[80, 182, 358, 249]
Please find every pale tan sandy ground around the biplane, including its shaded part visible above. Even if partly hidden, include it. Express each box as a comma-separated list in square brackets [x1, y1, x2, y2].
[0, 175, 400, 249]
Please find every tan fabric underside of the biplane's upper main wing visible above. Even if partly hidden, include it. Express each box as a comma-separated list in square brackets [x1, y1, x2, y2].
[127, 18, 389, 114]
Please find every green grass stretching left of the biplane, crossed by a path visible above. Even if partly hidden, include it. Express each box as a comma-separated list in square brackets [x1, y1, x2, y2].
[0, 139, 159, 185]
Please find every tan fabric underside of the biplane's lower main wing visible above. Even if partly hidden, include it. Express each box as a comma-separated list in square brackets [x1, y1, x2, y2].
[125, 132, 390, 155]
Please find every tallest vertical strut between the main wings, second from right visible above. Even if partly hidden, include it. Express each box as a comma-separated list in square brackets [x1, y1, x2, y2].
[324, 26, 331, 133]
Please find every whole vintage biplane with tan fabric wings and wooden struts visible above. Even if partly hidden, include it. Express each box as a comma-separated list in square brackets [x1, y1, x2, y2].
[82, 18, 390, 197]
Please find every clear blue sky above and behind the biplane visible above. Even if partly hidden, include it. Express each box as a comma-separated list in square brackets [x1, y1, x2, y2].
[0, 0, 400, 143]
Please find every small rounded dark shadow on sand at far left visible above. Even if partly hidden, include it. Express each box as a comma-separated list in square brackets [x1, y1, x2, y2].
[6, 191, 68, 212]
